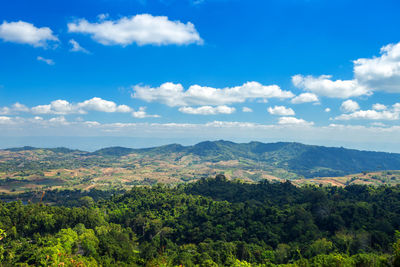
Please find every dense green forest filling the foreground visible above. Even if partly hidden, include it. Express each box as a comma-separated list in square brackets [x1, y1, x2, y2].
[0, 175, 400, 266]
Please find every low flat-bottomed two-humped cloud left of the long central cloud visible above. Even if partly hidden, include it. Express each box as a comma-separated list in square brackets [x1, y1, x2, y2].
[31, 97, 132, 115]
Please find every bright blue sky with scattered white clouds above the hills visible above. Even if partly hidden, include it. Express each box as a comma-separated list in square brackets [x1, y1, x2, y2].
[0, 0, 400, 153]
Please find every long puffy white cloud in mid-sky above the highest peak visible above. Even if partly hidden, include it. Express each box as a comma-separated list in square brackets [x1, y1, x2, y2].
[132, 82, 294, 107]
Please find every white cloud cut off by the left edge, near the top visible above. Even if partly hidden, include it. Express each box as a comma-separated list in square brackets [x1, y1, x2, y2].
[0, 21, 59, 47]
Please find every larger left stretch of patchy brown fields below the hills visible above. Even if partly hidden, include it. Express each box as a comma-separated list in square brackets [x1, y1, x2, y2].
[0, 155, 284, 193]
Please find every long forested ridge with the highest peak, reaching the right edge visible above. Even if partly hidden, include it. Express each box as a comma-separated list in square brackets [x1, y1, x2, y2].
[65, 140, 400, 177]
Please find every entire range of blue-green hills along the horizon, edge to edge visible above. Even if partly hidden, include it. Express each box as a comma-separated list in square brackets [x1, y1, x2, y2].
[0, 140, 400, 178]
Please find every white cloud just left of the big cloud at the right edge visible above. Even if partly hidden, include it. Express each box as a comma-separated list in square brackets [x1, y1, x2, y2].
[292, 75, 372, 98]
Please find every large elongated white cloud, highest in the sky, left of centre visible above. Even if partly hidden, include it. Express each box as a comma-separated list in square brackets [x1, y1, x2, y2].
[68, 14, 202, 46]
